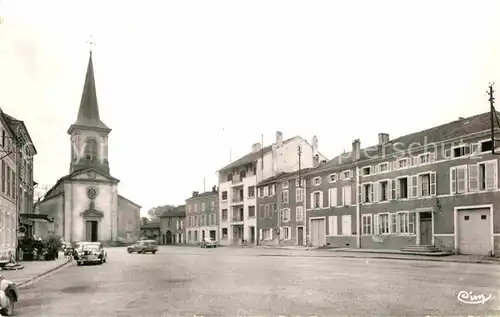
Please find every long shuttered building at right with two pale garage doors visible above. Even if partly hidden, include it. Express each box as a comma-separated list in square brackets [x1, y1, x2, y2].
[306, 112, 500, 255]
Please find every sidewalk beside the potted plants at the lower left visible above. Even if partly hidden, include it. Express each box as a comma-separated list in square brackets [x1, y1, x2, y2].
[0, 252, 68, 287]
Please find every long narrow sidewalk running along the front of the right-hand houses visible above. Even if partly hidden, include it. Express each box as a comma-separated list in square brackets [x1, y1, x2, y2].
[259, 246, 500, 265]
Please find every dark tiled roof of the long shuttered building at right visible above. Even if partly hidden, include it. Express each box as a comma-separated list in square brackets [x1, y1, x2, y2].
[310, 111, 500, 173]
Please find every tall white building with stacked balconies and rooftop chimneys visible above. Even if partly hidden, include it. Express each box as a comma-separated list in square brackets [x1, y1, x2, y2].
[218, 131, 326, 245]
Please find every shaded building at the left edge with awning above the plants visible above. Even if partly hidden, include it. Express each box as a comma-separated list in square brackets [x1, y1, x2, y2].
[0, 109, 40, 258]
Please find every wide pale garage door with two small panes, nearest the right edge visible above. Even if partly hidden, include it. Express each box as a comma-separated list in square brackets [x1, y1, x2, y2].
[458, 209, 491, 255]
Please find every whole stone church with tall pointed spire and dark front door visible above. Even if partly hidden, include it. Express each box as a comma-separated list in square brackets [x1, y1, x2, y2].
[35, 52, 141, 245]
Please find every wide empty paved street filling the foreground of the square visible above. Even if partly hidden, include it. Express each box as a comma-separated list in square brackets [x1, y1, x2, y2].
[16, 247, 500, 316]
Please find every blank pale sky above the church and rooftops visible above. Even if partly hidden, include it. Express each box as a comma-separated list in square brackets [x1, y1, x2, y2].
[0, 0, 500, 214]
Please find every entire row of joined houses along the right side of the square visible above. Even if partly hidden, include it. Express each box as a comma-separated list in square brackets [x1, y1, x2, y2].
[157, 112, 500, 255]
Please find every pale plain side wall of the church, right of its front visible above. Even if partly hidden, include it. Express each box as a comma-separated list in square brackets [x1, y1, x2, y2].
[118, 196, 141, 243]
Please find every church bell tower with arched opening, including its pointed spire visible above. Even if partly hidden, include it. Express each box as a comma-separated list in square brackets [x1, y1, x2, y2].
[68, 48, 111, 174]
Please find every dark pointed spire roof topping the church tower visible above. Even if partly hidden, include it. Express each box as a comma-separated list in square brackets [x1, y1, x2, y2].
[68, 52, 111, 133]
